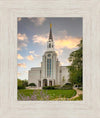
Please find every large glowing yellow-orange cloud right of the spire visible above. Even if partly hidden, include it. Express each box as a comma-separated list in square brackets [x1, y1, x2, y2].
[55, 36, 81, 49]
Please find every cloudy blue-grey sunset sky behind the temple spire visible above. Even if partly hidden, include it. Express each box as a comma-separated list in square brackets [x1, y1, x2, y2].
[17, 17, 83, 80]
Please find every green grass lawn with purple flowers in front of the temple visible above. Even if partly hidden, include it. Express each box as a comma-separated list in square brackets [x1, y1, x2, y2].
[18, 89, 76, 100]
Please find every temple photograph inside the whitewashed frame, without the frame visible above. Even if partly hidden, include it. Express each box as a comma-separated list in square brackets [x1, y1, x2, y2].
[17, 17, 83, 101]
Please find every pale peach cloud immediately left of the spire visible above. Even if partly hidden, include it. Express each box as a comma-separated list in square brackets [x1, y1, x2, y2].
[32, 35, 48, 45]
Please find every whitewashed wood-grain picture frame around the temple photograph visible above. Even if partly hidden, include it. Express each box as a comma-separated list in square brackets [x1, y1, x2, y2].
[0, 0, 100, 118]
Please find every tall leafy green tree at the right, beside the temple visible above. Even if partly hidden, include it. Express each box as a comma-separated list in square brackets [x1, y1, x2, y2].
[68, 40, 83, 86]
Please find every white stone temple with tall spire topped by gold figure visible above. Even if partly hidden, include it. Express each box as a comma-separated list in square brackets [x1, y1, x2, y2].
[28, 24, 69, 87]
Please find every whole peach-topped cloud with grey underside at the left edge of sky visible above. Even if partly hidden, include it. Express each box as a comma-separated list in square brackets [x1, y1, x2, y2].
[17, 33, 28, 50]
